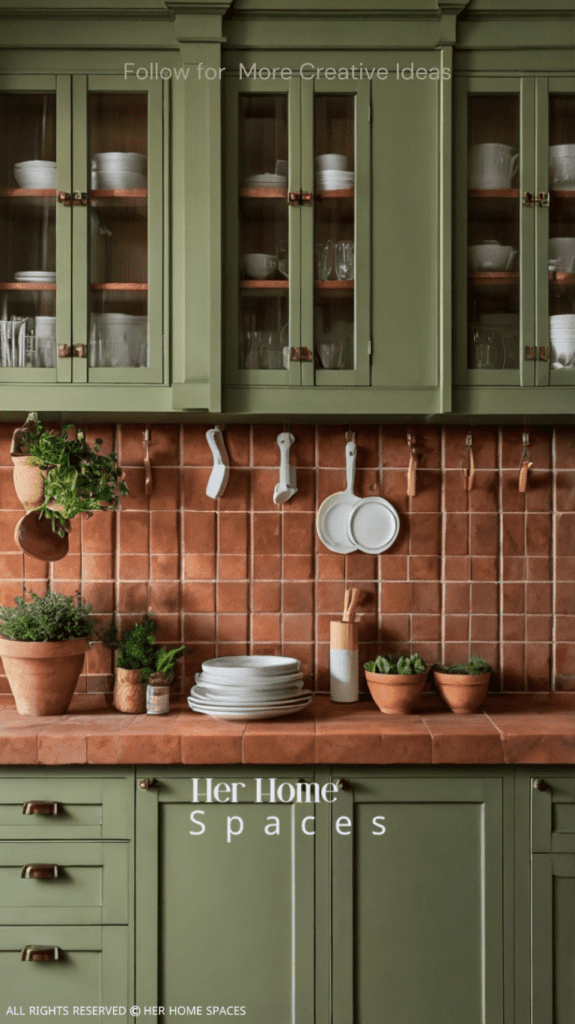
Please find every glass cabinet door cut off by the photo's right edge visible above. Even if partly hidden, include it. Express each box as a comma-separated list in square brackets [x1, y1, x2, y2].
[535, 79, 575, 386]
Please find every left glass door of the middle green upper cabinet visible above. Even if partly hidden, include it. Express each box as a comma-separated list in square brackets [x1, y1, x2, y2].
[225, 79, 300, 385]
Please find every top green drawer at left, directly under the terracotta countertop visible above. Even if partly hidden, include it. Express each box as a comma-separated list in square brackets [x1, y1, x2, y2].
[0, 773, 132, 840]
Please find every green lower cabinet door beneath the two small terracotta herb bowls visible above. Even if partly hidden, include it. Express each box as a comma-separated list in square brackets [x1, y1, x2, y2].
[331, 773, 513, 1024]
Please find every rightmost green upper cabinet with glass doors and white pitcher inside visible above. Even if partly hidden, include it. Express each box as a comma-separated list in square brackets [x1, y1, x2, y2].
[454, 76, 575, 413]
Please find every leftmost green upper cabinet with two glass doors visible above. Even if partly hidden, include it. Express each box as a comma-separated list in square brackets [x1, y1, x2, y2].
[0, 60, 167, 412]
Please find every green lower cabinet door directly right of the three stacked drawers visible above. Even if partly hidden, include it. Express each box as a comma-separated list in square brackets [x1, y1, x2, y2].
[136, 768, 314, 1024]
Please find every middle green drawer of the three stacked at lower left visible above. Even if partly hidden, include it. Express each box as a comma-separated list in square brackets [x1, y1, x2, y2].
[0, 843, 129, 925]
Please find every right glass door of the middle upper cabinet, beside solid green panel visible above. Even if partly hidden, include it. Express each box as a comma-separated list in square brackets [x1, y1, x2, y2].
[302, 78, 370, 386]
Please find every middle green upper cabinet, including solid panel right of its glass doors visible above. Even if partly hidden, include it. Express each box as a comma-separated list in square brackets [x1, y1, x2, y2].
[218, 50, 450, 415]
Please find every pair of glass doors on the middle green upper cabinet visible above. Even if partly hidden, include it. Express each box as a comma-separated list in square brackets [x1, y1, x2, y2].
[225, 74, 370, 387]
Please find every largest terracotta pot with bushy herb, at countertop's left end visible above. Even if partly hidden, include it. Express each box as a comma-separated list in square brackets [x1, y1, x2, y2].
[0, 591, 93, 715]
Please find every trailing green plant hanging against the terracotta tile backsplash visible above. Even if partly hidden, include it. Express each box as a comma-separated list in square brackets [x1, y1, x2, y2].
[17, 414, 128, 537]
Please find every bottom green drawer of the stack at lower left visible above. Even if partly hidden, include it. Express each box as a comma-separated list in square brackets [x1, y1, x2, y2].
[0, 925, 132, 1007]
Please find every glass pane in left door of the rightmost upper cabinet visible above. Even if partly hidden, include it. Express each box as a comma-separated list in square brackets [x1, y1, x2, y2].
[467, 92, 521, 371]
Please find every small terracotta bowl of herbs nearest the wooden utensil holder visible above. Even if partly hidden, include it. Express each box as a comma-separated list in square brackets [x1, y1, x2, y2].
[363, 654, 428, 715]
